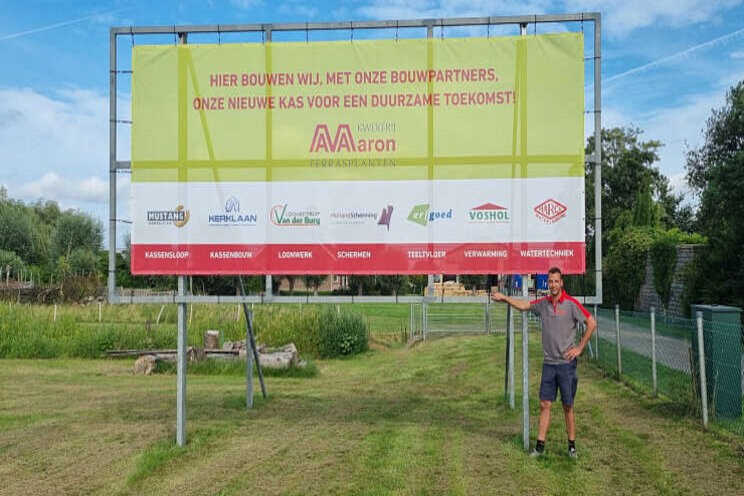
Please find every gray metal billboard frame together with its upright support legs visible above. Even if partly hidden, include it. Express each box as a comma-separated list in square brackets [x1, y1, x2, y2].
[108, 12, 602, 450]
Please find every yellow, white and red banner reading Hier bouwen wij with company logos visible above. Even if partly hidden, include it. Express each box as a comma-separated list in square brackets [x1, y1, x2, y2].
[131, 33, 585, 274]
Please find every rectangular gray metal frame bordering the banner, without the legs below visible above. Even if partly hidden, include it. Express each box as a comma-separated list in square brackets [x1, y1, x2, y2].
[108, 13, 602, 305]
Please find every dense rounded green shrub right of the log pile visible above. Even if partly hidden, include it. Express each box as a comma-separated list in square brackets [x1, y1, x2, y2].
[319, 308, 369, 358]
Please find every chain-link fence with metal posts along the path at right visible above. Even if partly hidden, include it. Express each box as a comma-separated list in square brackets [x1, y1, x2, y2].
[592, 306, 744, 434]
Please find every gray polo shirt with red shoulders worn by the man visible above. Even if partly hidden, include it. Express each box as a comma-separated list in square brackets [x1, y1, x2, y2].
[530, 291, 590, 364]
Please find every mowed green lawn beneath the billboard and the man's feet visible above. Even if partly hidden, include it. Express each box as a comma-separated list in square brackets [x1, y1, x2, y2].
[0, 333, 744, 495]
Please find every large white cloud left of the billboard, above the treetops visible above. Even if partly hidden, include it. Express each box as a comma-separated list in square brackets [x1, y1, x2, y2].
[0, 88, 130, 247]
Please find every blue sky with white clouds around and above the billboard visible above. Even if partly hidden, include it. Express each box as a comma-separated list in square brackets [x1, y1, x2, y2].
[0, 0, 744, 247]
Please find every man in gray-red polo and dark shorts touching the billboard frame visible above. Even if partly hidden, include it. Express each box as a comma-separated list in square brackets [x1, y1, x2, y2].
[492, 267, 597, 458]
